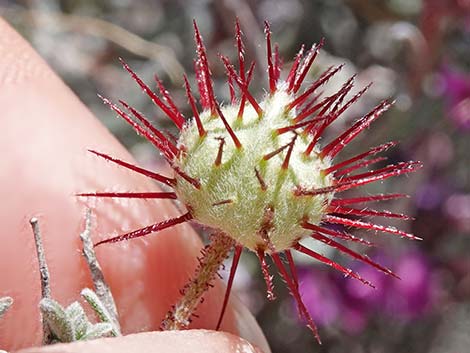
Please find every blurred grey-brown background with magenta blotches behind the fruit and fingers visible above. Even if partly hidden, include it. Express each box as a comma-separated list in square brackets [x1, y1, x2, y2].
[0, 0, 470, 353]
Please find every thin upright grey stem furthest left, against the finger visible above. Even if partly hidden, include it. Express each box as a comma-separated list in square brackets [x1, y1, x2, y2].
[29, 217, 52, 344]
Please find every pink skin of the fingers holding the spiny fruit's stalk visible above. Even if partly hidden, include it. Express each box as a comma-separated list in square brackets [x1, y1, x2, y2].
[0, 20, 269, 353]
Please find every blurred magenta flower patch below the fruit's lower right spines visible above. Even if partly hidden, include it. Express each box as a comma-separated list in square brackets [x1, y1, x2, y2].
[293, 250, 437, 334]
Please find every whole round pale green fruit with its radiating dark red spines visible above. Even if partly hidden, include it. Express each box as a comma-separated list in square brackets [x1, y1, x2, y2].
[80, 21, 421, 338]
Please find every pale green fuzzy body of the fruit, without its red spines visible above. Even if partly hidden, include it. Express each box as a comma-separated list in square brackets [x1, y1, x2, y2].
[175, 85, 333, 252]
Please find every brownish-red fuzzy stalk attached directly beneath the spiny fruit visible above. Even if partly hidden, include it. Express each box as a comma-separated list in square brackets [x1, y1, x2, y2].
[161, 232, 234, 330]
